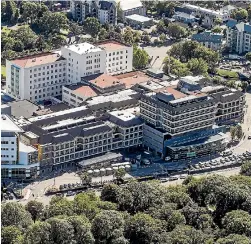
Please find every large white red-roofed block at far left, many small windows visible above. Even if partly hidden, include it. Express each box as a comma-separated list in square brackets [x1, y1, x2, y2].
[6, 53, 67, 102]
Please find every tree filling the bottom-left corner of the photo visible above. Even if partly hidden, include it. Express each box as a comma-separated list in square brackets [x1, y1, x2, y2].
[1, 225, 23, 244]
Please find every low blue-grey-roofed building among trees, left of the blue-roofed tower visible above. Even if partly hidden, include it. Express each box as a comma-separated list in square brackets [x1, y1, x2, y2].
[191, 31, 223, 51]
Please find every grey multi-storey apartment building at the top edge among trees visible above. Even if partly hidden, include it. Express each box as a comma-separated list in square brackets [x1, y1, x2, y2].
[71, 0, 117, 24]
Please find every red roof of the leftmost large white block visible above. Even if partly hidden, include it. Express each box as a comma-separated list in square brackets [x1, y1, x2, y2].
[12, 53, 64, 68]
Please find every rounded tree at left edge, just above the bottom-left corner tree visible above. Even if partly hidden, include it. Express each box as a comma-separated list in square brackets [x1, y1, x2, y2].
[1, 202, 32, 228]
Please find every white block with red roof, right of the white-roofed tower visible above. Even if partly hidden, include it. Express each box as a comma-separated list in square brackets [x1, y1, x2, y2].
[98, 41, 133, 74]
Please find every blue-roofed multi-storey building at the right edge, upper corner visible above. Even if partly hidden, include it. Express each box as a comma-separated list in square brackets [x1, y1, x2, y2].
[226, 20, 251, 54]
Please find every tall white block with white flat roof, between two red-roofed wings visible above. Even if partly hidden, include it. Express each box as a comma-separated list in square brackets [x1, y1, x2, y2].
[61, 42, 106, 83]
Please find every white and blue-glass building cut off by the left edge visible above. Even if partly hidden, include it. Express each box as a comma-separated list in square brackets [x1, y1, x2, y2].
[1, 115, 39, 178]
